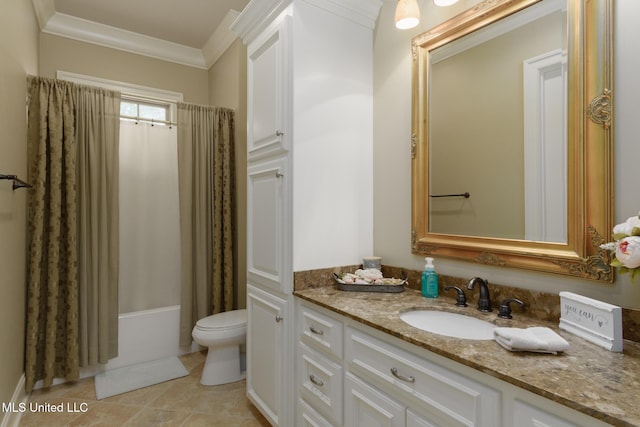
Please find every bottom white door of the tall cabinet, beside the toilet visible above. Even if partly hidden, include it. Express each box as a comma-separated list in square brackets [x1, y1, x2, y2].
[247, 285, 291, 426]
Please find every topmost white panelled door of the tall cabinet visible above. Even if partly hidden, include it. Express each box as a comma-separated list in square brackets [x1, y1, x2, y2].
[247, 16, 291, 159]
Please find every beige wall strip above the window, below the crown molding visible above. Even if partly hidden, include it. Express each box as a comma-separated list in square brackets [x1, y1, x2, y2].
[40, 33, 209, 105]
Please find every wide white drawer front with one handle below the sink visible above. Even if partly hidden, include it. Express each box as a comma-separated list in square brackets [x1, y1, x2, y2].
[345, 328, 501, 427]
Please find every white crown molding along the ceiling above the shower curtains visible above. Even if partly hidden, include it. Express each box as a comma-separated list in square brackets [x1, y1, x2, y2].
[32, 0, 239, 70]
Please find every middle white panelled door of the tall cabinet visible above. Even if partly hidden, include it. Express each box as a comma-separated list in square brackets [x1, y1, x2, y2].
[247, 157, 293, 294]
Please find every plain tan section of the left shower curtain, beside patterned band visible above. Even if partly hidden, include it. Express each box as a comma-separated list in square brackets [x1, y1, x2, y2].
[76, 86, 120, 366]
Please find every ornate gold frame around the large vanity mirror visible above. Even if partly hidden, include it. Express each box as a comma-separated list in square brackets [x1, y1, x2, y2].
[411, 0, 614, 283]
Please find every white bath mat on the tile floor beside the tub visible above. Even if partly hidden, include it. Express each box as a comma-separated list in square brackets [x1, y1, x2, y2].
[94, 357, 189, 400]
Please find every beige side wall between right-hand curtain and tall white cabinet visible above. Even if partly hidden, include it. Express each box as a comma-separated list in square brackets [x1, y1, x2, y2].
[209, 39, 247, 308]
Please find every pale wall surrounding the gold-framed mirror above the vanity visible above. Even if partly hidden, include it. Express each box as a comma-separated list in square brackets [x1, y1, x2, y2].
[373, 0, 640, 308]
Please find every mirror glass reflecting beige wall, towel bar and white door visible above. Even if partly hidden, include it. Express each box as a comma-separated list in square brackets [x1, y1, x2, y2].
[427, 0, 568, 243]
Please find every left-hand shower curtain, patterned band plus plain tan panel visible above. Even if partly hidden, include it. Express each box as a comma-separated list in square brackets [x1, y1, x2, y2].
[25, 76, 120, 391]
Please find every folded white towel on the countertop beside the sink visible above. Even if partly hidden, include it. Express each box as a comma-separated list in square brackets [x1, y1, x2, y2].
[493, 327, 569, 354]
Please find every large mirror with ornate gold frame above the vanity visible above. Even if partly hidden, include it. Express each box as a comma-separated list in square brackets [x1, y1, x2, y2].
[411, 0, 614, 283]
